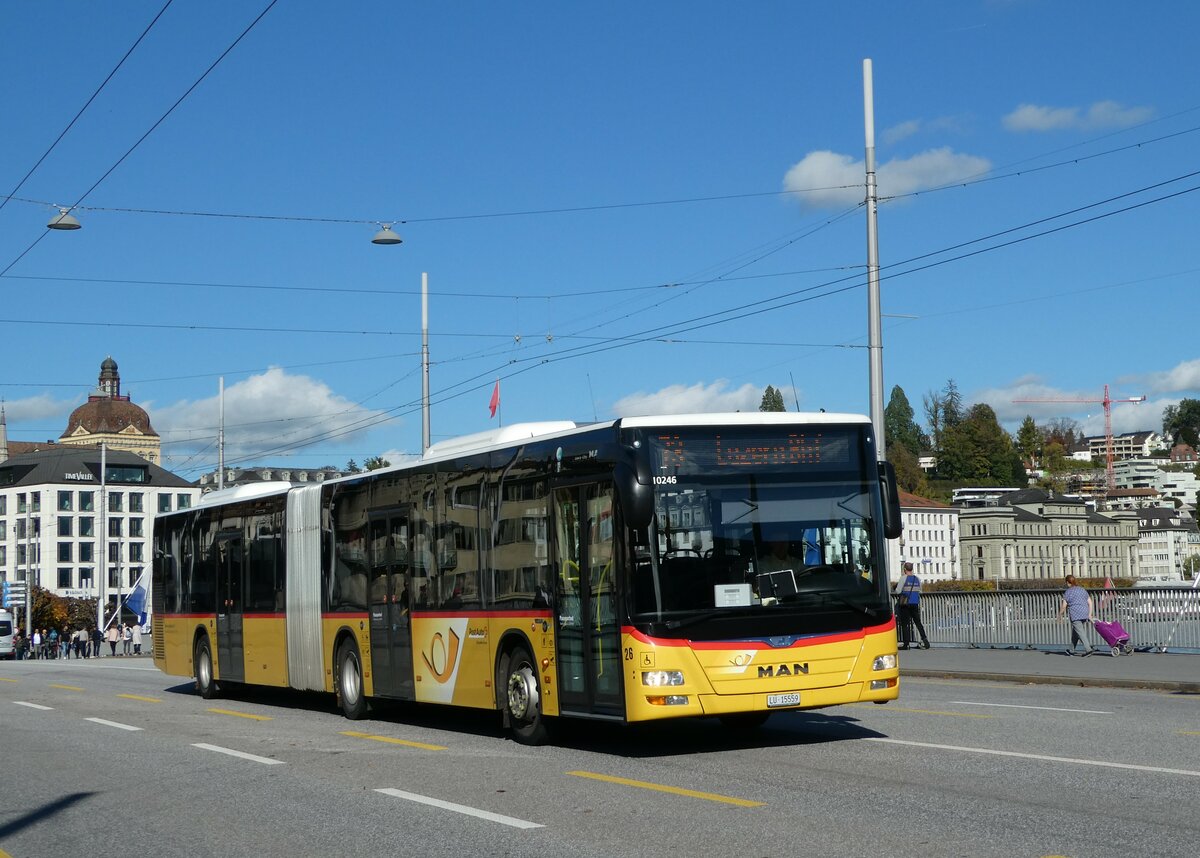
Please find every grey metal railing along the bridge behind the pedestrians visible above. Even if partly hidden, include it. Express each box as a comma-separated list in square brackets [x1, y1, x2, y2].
[902, 587, 1200, 653]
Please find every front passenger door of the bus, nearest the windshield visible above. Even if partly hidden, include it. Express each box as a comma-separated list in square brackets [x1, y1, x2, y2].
[553, 482, 623, 715]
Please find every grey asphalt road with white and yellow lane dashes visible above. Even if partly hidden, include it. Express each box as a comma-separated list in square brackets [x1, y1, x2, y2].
[0, 659, 1200, 858]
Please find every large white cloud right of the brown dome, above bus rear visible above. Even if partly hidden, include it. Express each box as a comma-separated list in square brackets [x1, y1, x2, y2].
[148, 367, 379, 462]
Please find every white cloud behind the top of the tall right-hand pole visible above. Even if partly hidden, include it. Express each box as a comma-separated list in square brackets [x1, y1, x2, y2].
[784, 146, 991, 208]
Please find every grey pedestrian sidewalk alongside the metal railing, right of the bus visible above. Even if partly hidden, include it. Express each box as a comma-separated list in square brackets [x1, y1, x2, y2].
[900, 646, 1200, 694]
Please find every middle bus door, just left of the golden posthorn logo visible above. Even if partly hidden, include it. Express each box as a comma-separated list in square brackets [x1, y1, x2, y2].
[370, 514, 416, 700]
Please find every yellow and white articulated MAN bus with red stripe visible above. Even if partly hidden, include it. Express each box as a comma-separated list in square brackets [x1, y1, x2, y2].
[151, 413, 900, 744]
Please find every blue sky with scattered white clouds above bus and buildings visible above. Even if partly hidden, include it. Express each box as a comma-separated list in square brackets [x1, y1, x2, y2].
[0, 0, 1200, 478]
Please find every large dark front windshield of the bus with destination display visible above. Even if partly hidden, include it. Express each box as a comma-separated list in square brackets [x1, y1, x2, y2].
[632, 426, 890, 635]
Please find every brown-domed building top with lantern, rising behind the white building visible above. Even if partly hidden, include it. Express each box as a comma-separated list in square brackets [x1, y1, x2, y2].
[59, 356, 162, 464]
